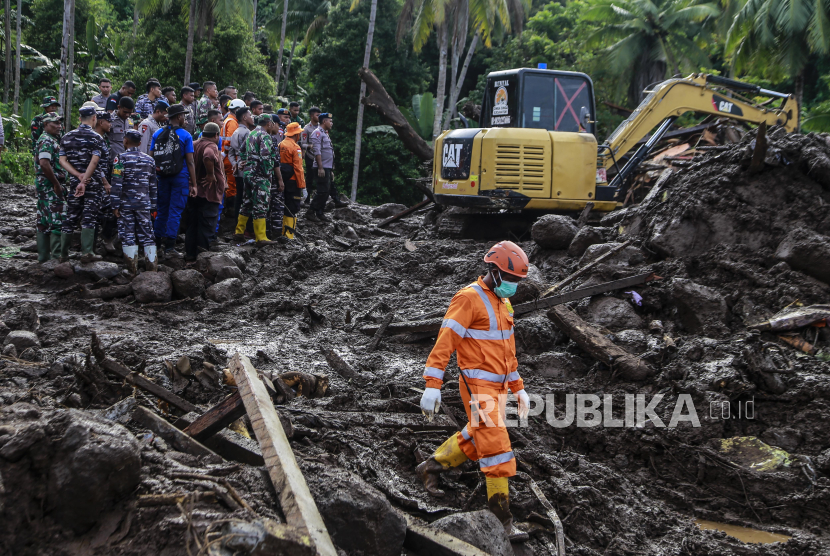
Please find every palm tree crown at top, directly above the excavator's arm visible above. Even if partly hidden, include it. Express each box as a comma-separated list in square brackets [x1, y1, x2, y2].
[583, 0, 720, 105]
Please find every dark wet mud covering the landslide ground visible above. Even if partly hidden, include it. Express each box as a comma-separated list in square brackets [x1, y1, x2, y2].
[0, 127, 830, 556]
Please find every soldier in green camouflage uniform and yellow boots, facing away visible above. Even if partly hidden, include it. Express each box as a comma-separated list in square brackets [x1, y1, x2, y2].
[233, 114, 278, 247]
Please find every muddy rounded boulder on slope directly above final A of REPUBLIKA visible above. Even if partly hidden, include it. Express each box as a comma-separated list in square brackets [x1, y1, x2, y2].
[671, 278, 729, 334]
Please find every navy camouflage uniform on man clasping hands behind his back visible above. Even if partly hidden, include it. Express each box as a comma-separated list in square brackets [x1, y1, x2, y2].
[60, 124, 106, 234]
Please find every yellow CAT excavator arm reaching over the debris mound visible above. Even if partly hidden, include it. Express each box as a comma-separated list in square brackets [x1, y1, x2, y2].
[597, 74, 798, 182]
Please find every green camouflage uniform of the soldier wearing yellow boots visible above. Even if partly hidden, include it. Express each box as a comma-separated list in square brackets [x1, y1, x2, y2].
[239, 126, 277, 220]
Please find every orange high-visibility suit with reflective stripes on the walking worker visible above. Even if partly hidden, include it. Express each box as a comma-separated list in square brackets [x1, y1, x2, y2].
[424, 278, 524, 477]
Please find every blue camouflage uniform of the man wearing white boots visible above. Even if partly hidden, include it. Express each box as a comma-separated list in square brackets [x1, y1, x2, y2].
[109, 147, 158, 245]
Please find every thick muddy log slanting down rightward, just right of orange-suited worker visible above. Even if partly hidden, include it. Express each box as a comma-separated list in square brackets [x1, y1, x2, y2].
[548, 305, 655, 380]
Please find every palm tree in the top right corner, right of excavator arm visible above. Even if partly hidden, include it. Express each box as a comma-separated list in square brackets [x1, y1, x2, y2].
[726, 0, 830, 120]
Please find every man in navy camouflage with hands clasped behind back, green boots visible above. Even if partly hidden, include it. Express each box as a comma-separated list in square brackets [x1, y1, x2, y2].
[60, 106, 105, 263]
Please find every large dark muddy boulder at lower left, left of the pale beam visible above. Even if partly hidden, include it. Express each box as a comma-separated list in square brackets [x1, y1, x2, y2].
[46, 409, 141, 533]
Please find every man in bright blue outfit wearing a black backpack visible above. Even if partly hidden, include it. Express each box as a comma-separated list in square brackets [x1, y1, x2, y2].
[150, 104, 196, 257]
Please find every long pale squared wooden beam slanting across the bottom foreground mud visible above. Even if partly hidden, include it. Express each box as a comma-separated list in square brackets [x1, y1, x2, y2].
[230, 353, 337, 556]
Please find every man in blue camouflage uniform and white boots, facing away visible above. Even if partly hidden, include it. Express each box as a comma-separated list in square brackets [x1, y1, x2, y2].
[109, 129, 158, 275]
